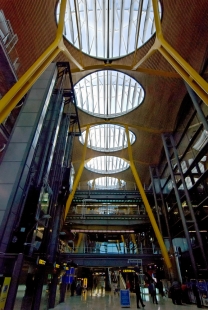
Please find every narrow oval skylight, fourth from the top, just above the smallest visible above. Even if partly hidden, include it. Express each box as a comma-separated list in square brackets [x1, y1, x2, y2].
[85, 156, 129, 174]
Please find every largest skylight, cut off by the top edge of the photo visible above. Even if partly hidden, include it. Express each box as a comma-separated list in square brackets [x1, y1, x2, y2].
[57, 0, 161, 59]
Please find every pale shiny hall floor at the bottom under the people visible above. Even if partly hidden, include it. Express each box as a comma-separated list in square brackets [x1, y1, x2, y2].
[50, 292, 197, 310]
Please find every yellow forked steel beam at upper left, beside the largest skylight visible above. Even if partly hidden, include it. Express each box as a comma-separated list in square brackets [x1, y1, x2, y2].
[0, 0, 83, 123]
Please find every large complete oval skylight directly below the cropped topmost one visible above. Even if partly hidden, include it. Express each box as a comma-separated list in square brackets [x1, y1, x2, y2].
[74, 70, 144, 118]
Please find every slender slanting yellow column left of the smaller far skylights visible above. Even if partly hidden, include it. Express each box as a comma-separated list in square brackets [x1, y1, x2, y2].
[64, 126, 90, 218]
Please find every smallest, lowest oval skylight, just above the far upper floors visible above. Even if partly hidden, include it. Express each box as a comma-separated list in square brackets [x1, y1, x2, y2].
[87, 177, 126, 189]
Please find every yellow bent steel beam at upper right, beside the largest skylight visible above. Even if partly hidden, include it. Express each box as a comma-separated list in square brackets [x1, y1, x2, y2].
[152, 0, 208, 105]
